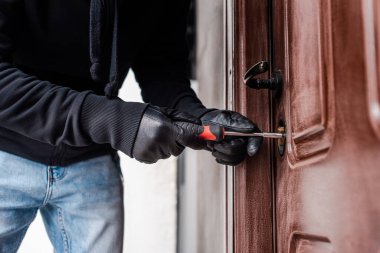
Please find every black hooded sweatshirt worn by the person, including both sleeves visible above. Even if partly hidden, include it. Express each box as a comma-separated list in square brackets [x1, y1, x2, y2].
[0, 0, 204, 166]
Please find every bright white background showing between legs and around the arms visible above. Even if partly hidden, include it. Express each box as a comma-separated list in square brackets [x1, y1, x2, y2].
[19, 73, 177, 253]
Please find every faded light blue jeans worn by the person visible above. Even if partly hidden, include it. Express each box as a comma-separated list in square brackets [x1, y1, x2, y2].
[0, 151, 124, 253]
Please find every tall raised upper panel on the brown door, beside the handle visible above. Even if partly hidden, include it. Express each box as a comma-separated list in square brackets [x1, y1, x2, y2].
[284, 0, 334, 168]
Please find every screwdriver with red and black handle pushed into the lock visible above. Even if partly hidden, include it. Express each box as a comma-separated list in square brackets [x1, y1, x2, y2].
[198, 125, 285, 142]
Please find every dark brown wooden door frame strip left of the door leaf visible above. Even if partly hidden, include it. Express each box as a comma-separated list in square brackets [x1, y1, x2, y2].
[229, 0, 273, 253]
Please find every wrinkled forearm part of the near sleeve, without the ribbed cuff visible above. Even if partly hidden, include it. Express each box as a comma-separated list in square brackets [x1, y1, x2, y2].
[0, 62, 91, 146]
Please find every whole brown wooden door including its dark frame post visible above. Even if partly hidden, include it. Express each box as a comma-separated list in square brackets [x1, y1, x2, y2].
[234, 0, 380, 253]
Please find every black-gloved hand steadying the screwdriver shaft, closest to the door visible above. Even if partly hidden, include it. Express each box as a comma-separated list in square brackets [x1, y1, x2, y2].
[200, 110, 263, 165]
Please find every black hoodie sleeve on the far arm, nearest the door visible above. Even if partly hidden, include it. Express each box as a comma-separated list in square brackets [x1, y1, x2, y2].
[132, 0, 205, 116]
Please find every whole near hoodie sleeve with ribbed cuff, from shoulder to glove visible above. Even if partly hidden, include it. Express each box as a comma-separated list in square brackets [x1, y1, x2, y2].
[0, 0, 146, 155]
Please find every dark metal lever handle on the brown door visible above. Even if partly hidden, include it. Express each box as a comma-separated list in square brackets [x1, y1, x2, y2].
[244, 61, 282, 93]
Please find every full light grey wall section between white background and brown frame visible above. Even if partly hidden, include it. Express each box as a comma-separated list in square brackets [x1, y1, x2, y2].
[179, 0, 226, 253]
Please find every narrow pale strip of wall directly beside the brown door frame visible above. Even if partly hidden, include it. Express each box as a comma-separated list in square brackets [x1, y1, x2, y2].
[197, 0, 226, 253]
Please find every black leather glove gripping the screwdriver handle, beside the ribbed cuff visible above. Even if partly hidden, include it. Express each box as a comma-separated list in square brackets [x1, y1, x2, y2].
[132, 106, 206, 163]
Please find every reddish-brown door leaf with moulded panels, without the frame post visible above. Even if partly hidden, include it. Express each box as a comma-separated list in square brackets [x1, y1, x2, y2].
[272, 0, 380, 252]
